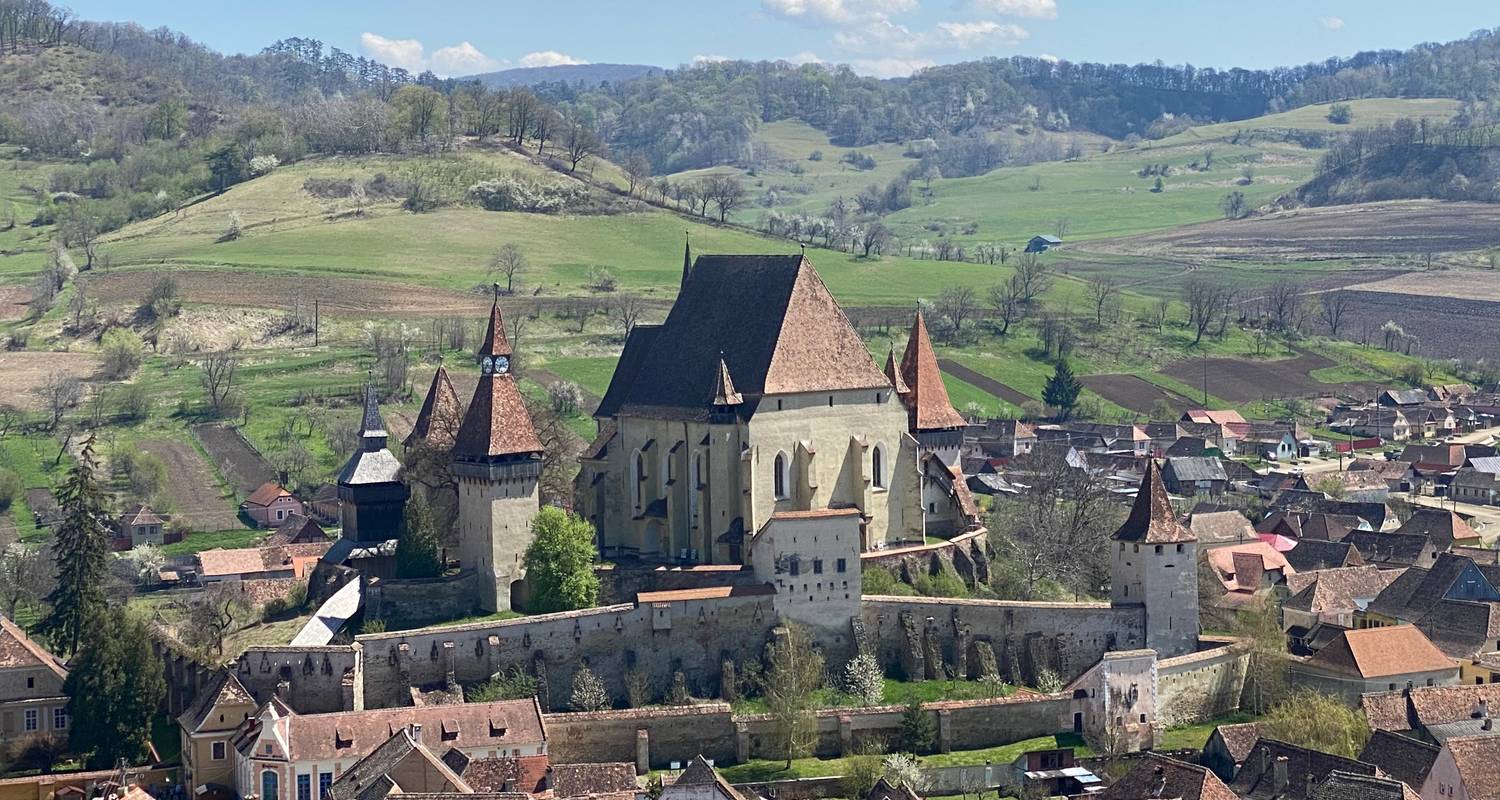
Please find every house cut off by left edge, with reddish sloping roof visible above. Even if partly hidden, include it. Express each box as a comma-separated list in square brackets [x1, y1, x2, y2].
[0, 617, 69, 747]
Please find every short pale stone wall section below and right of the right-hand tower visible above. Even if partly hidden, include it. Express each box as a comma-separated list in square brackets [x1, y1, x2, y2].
[1157, 638, 1250, 726]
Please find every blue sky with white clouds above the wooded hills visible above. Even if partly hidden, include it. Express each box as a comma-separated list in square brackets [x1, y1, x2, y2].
[68, 0, 1500, 77]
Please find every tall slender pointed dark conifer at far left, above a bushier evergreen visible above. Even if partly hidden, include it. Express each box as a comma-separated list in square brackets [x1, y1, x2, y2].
[41, 437, 110, 653]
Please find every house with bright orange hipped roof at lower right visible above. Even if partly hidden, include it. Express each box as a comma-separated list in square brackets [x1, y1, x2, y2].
[1292, 624, 1458, 704]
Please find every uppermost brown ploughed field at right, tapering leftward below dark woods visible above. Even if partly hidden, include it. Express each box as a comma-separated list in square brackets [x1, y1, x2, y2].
[1086, 200, 1500, 263]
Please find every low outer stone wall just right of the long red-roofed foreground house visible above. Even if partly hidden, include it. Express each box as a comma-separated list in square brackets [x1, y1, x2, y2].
[546, 702, 735, 771]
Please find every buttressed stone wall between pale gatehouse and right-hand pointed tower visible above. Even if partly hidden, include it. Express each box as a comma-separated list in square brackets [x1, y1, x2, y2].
[861, 596, 1145, 683]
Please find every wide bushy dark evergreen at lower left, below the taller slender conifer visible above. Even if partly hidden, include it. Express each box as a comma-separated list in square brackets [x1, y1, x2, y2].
[63, 608, 167, 770]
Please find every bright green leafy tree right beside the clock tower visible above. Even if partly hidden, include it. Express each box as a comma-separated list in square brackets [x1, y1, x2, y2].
[525, 506, 599, 614]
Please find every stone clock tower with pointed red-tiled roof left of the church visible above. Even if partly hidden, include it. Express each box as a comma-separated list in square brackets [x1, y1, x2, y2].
[453, 294, 543, 611]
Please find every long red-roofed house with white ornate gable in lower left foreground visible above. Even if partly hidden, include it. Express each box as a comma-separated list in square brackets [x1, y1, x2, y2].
[231, 698, 548, 800]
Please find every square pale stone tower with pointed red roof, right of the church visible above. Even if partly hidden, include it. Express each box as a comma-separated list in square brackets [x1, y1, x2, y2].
[1110, 459, 1199, 659]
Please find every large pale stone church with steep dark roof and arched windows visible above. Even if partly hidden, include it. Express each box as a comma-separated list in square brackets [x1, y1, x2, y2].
[576, 255, 975, 564]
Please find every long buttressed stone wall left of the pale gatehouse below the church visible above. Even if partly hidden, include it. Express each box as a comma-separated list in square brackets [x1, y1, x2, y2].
[357, 593, 780, 710]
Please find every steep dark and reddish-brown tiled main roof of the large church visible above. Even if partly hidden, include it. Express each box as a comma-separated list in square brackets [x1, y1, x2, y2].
[597, 255, 891, 416]
